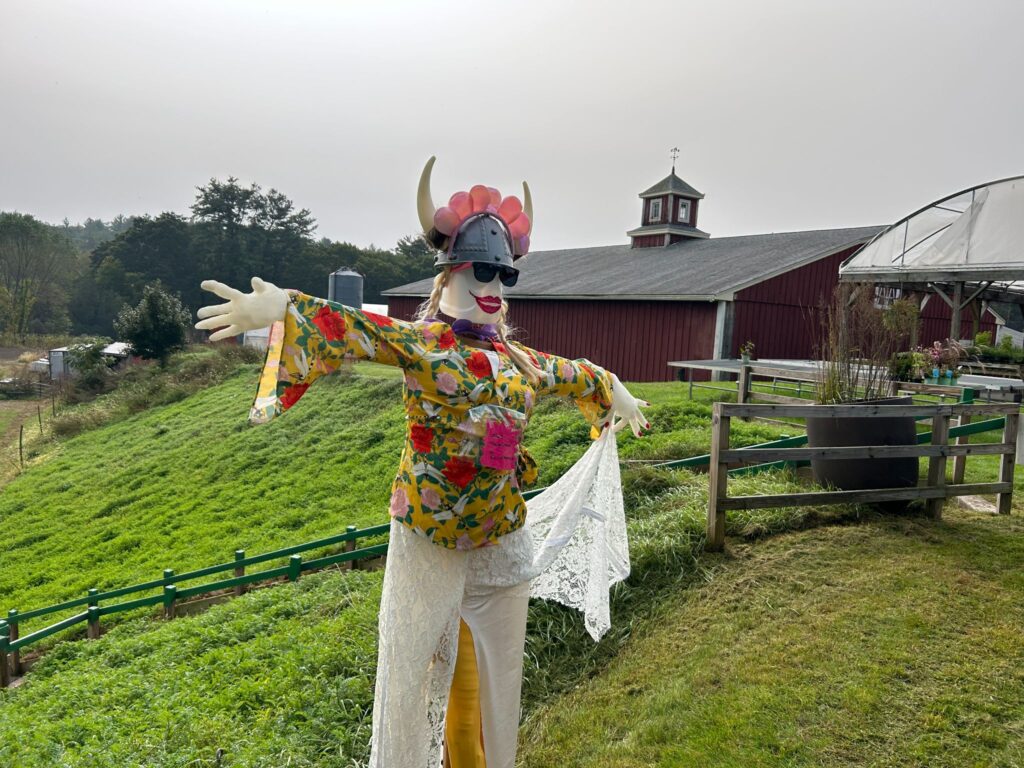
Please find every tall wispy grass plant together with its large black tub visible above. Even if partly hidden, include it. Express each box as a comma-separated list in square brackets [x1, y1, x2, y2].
[806, 284, 924, 490]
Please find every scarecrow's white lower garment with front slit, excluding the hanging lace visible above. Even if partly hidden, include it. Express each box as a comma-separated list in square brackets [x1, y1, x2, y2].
[370, 521, 532, 768]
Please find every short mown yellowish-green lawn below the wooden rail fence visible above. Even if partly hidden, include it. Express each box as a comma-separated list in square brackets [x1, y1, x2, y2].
[520, 512, 1024, 768]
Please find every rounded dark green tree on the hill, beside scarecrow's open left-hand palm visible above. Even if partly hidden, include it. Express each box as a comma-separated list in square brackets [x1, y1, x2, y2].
[114, 283, 191, 368]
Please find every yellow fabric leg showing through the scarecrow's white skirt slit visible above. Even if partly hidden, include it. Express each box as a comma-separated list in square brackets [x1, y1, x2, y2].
[444, 621, 486, 768]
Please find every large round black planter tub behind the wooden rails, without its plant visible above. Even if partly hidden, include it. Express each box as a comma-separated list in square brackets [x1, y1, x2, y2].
[807, 397, 918, 499]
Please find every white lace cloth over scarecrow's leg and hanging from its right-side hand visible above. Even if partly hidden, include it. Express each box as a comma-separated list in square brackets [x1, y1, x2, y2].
[370, 430, 630, 768]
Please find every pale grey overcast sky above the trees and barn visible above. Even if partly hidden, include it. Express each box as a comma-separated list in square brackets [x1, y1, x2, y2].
[0, 0, 1024, 250]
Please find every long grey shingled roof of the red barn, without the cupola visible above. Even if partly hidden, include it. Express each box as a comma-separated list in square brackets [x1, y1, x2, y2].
[384, 226, 883, 301]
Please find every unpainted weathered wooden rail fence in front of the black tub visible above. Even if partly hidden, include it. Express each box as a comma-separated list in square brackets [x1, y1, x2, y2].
[707, 402, 1020, 551]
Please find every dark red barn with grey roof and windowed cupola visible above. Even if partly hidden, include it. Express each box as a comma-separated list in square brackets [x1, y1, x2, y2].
[384, 169, 992, 381]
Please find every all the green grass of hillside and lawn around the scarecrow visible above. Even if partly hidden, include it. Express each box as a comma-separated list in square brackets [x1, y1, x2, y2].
[0, 358, 1024, 768]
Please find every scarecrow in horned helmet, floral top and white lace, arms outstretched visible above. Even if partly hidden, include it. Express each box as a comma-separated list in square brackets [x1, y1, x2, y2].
[196, 158, 648, 768]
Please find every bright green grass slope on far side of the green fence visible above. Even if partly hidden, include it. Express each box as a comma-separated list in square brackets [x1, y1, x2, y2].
[0, 366, 790, 634]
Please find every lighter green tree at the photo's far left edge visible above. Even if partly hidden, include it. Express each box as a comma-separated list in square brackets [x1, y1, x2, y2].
[0, 213, 78, 336]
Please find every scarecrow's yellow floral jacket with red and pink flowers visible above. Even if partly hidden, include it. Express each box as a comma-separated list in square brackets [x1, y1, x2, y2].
[250, 292, 611, 549]
